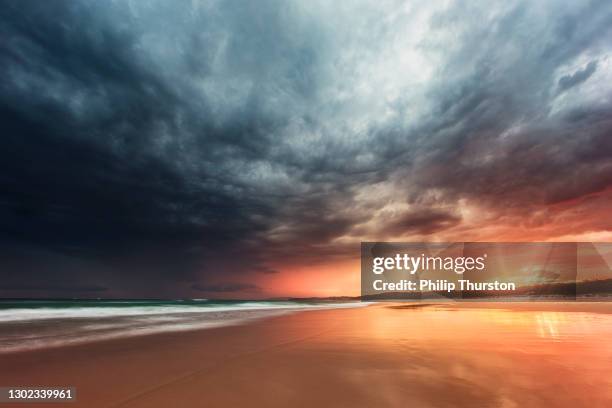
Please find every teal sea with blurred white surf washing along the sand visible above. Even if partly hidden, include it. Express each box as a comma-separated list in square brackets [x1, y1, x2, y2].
[0, 299, 364, 353]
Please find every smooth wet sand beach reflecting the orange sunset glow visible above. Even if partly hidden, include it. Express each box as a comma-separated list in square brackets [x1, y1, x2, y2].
[0, 303, 612, 408]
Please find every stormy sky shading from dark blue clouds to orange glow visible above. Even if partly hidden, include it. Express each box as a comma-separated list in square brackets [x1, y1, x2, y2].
[0, 0, 612, 298]
